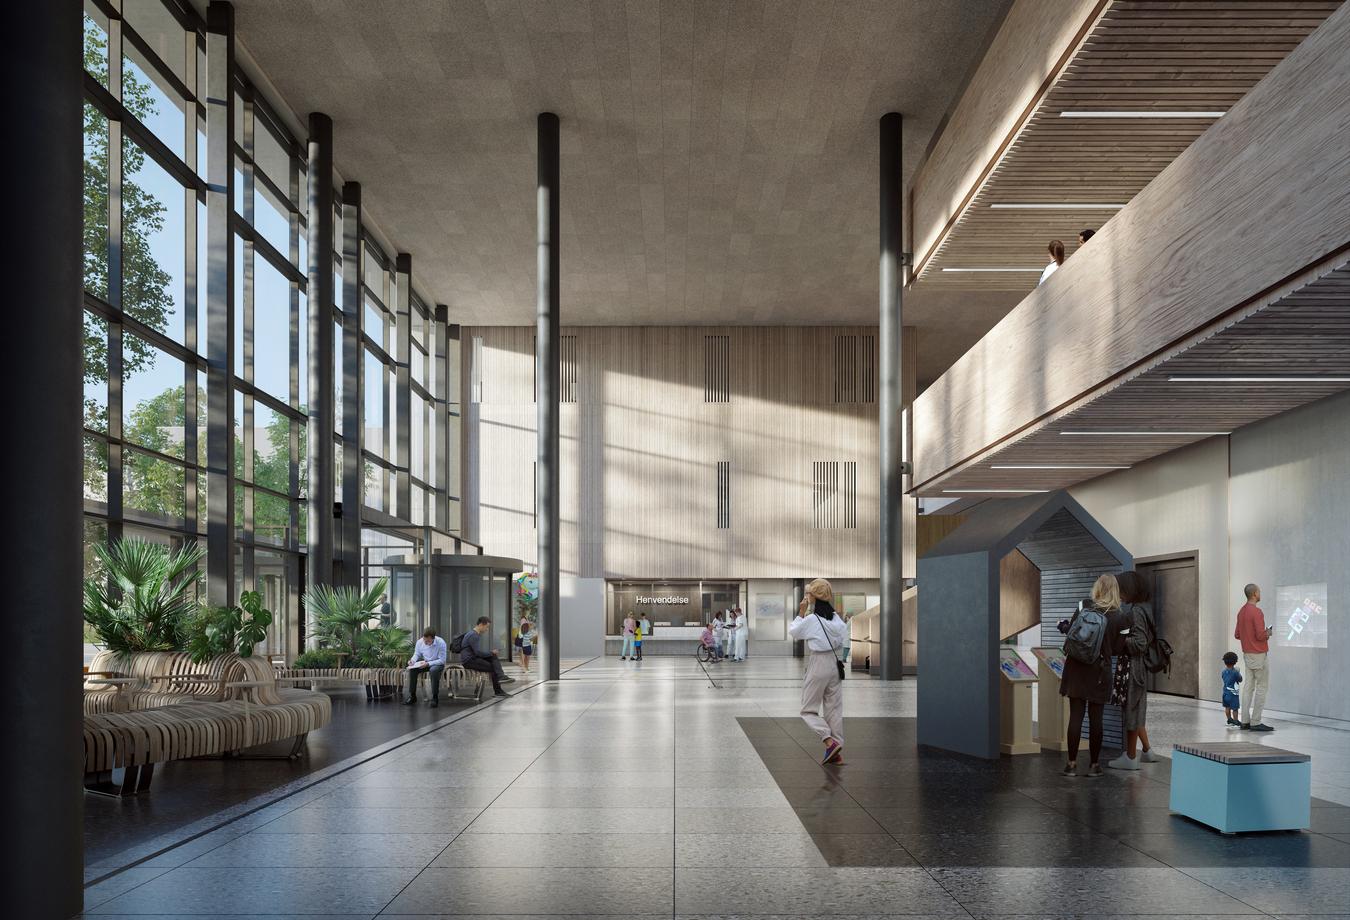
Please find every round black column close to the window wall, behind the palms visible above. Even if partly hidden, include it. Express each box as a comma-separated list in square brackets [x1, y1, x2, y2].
[305, 112, 338, 594]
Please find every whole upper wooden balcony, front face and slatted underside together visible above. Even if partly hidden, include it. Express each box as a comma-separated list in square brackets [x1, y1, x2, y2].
[911, 0, 1341, 290]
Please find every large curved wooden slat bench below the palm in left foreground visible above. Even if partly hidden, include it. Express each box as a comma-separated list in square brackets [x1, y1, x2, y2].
[84, 653, 332, 794]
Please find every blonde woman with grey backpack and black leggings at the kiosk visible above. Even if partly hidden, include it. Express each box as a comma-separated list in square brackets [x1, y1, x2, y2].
[1060, 576, 1122, 777]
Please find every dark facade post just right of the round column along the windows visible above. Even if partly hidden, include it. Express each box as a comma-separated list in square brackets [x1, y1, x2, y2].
[338, 182, 366, 588]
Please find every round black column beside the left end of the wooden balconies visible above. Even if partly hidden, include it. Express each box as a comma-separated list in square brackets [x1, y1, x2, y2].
[879, 112, 906, 681]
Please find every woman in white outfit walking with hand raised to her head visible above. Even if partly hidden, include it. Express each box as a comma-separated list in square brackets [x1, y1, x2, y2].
[787, 578, 848, 763]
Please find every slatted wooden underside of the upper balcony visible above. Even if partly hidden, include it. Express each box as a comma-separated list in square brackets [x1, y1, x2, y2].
[915, 0, 1341, 290]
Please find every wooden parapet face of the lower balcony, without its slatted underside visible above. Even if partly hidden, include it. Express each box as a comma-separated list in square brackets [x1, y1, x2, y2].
[914, 5, 1350, 493]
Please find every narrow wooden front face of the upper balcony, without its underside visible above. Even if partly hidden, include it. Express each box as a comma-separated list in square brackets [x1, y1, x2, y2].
[911, 0, 1106, 272]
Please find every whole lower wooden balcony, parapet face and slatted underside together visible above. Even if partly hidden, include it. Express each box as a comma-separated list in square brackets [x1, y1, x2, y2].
[914, 5, 1350, 494]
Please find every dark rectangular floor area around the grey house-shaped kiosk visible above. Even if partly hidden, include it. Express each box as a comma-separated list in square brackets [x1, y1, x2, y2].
[737, 717, 1350, 869]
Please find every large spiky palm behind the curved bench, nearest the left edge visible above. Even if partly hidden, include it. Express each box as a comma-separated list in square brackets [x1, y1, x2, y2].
[84, 539, 205, 653]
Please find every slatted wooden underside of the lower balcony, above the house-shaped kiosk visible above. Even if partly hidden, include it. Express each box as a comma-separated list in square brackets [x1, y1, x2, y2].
[919, 261, 1350, 494]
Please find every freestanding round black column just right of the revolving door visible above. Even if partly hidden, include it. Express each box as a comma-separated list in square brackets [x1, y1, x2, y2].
[535, 112, 562, 681]
